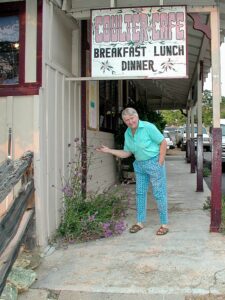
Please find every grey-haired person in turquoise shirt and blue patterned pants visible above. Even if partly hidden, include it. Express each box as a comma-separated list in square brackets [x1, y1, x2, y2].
[96, 107, 169, 235]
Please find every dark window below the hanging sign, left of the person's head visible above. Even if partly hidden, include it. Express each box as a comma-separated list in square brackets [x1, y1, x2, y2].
[99, 80, 118, 132]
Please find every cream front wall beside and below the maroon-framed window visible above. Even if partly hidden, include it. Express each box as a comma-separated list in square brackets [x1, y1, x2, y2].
[0, 0, 38, 163]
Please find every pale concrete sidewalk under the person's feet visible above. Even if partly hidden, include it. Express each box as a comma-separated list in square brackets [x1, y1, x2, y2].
[19, 155, 225, 300]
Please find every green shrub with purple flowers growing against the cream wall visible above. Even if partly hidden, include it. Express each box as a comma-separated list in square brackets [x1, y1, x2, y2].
[57, 139, 127, 241]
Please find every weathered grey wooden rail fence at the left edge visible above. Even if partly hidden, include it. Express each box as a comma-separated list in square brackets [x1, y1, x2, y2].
[0, 152, 34, 295]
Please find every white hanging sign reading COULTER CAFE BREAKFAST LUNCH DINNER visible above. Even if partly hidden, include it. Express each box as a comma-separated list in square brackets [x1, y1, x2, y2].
[92, 6, 187, 78]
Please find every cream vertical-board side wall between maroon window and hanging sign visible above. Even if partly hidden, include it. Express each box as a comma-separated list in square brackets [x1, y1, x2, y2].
[35, 1, 80, 246]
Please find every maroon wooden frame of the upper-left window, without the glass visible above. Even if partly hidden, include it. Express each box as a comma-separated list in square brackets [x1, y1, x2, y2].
[0, 0, 42, 97]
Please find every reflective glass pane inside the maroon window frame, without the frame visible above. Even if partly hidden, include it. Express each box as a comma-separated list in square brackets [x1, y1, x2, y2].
[0, 16, 19, 84]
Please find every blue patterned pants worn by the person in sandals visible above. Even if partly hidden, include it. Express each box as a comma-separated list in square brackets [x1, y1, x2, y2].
[133, 156, 168, 224]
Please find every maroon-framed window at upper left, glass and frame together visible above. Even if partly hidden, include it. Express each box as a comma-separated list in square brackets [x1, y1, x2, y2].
[0, 0, 42, 96]
